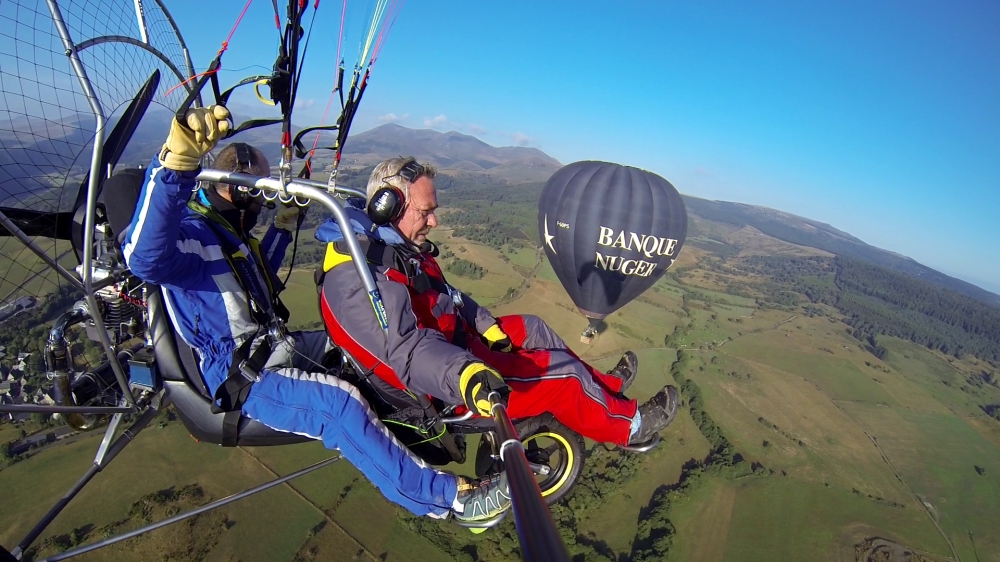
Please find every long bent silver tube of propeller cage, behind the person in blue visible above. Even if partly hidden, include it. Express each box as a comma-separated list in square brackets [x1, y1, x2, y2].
[45, 0, 135, 405]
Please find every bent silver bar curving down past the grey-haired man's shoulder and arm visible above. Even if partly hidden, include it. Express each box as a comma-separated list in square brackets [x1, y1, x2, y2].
[198, 169, 389, 337]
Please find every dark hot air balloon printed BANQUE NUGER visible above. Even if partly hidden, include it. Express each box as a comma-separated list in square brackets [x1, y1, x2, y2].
[538, 161, 687, 343]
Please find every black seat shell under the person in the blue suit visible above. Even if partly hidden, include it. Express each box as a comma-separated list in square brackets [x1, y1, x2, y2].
[146, 283, 313, 447]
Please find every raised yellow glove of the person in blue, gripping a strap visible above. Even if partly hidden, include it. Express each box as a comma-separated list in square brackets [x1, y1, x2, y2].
[160, 105, 230, 172]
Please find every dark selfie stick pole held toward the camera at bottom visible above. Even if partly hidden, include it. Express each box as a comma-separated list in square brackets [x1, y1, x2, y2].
[490, 392, 570, 562]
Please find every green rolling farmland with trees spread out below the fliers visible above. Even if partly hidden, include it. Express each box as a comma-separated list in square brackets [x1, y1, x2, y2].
[0, 133, 1000, 562]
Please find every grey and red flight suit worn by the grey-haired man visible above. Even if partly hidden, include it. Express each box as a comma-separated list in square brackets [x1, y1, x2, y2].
[316, 205, 637, 445]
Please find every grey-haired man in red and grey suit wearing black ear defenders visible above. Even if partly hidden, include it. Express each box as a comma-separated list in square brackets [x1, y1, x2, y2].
[316, 157, 678, 445]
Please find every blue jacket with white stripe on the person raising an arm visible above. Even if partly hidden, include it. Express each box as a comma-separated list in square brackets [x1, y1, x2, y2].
[123, 157, 291, 393]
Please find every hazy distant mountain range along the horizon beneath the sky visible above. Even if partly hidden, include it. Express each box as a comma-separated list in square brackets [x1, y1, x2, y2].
[0, 108, 1000, 306]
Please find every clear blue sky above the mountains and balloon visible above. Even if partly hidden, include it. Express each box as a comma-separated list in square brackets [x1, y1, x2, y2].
[167, 0, 1000, 292]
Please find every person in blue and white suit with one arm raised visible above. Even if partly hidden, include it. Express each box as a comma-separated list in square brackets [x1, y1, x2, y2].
[123, 106, 510, 522]
